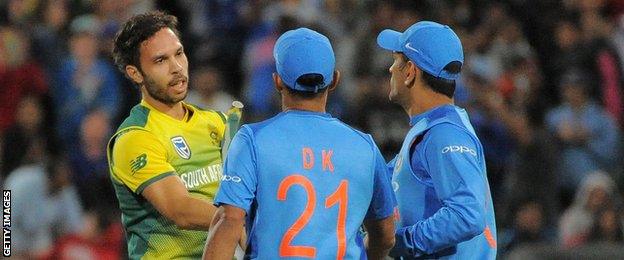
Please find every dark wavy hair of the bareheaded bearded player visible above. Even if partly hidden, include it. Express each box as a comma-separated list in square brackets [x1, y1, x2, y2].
[113, 11, 180, 75]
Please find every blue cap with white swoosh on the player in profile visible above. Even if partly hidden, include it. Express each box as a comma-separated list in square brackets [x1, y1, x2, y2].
[377, 21, 464, 80]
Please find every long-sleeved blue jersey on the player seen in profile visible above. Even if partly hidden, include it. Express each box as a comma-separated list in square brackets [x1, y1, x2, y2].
[389, 105, 496, 259]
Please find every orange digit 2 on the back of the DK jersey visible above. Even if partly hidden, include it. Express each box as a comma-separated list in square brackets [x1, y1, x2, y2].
[277, 175, 316, 258]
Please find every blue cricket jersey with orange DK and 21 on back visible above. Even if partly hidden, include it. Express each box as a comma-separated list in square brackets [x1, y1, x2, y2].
[215, 110, 396, 259]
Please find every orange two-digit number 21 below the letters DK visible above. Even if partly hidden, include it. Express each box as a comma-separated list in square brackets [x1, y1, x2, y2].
[277, 175, 349, 259]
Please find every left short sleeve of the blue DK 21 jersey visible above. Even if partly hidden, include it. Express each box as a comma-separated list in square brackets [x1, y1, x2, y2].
[214, 125, 258, 214]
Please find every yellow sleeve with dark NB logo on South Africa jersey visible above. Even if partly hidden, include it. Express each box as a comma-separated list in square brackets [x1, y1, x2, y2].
[111, 130, 175, 194]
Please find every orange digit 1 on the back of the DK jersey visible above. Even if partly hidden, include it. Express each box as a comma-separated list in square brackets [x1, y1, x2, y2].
[325, 180, 349, 260]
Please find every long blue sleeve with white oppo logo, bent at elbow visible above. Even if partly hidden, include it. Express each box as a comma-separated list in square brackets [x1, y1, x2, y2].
[396, 124, 489, 255]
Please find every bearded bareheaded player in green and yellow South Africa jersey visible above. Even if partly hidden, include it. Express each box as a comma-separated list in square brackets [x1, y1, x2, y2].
[108, 12, 228, 259]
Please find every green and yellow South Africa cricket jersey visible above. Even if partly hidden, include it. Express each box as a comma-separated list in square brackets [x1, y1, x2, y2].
[108, 101, 225, 259]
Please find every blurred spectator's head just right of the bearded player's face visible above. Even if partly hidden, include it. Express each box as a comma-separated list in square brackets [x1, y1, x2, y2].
[186, 66, 234, 112]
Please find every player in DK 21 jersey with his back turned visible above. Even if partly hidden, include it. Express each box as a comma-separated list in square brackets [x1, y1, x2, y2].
[204, 28, 395, 260]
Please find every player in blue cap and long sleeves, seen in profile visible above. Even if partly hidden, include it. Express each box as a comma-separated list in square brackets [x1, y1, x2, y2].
[377, 21, 496, 259]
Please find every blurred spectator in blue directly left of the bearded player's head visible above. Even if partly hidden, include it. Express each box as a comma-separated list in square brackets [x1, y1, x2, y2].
[53, 16, 120, 144]
